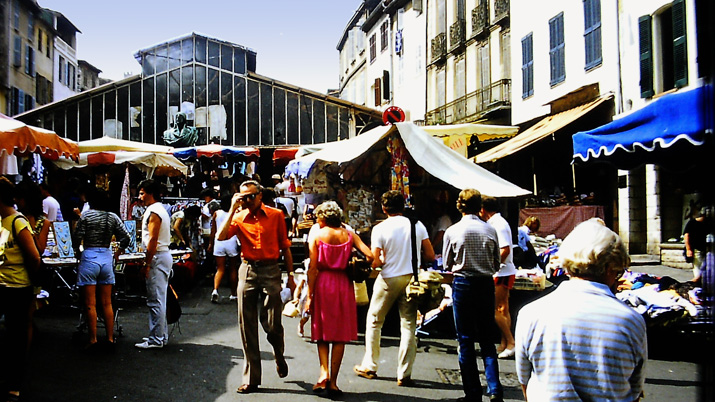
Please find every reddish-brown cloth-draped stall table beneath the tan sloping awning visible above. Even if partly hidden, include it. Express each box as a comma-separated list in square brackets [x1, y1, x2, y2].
[519, 205, 605, 239]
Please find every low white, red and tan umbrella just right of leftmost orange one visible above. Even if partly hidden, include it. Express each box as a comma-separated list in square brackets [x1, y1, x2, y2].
[54, 151, 189, 177]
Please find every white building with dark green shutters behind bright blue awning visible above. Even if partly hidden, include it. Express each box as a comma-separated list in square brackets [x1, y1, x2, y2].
[615, 0, 712, 255]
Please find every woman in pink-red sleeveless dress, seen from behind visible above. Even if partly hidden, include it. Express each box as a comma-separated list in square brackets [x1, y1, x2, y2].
[306, 201, 372, 396]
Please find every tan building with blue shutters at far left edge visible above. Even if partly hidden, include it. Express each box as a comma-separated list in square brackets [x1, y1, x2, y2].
[0, 0, 55, 116]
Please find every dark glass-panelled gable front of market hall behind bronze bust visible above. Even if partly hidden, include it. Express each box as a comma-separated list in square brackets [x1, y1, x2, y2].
[17, 33, 381, 147]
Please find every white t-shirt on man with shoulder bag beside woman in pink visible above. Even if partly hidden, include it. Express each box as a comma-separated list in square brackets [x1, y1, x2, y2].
[371, 215, 429, 278]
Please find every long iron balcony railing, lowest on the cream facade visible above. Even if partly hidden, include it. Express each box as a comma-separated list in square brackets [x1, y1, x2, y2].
[425, 79, 511, 125]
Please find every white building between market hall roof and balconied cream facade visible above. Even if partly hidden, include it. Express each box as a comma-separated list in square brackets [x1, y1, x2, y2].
[337, 0, 426, 123]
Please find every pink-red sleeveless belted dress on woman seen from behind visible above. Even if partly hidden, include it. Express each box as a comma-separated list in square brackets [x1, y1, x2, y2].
[310, 233, 357, 342]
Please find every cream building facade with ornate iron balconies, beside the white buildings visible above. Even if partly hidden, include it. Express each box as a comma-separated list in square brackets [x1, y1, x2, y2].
[425, 0, 512, 125]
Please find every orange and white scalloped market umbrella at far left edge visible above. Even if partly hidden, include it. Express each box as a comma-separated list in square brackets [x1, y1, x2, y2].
[0, 113, 79, 160]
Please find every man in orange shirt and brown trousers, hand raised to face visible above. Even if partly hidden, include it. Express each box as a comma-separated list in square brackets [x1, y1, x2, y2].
[218, 180, 295, 394]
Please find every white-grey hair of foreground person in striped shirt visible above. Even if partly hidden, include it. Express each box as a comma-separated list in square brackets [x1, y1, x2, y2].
[558, 219, 631, 280]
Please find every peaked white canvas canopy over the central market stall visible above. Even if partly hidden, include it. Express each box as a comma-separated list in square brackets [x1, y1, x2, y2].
[286, 122, 531, 197]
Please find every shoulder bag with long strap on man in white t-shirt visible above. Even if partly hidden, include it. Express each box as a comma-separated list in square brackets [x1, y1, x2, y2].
[405, 219, 444, 314]
